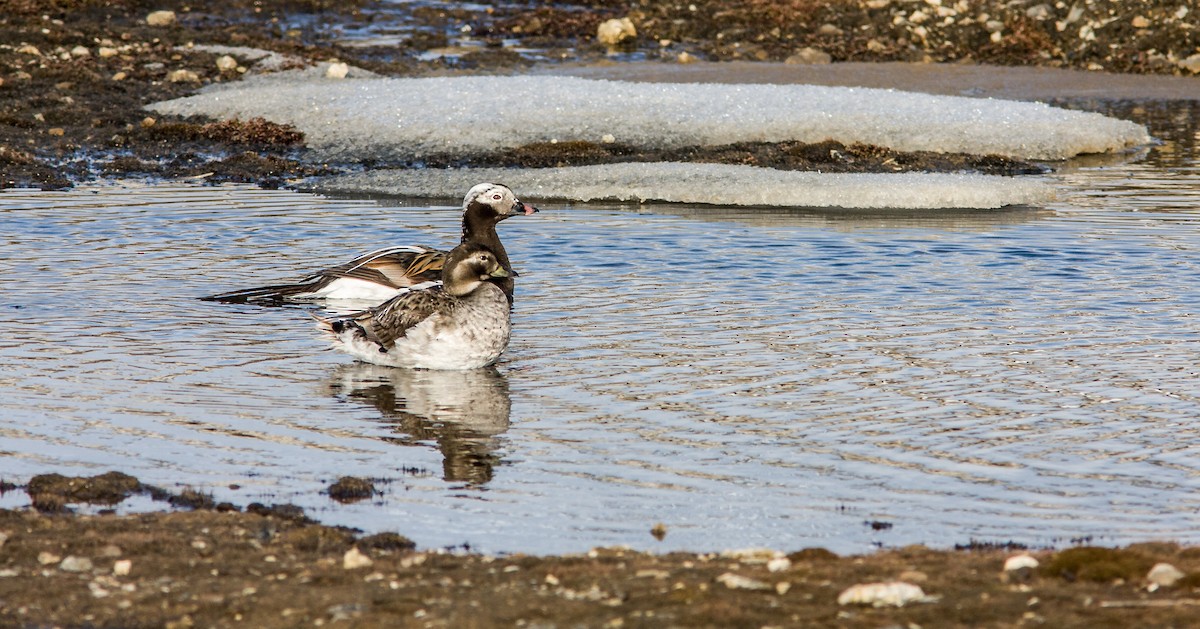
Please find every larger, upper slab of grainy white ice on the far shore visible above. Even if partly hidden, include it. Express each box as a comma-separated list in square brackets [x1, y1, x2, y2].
[150, 73, 1150, 161]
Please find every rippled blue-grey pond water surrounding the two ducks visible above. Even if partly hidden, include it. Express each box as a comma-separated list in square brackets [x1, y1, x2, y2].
[0, 104, 1200, 553]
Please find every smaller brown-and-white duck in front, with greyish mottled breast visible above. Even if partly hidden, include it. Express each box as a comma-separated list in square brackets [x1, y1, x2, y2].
[317, 242, 511, 370]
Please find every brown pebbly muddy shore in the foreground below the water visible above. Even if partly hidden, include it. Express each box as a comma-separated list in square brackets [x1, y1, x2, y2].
[0, 473, 1200, 628]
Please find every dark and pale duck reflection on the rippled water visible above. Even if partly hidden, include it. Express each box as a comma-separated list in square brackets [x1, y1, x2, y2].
[329, 363, 512, 485]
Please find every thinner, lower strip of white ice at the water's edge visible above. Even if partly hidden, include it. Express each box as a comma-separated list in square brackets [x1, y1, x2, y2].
[319, 162, 1055, 209]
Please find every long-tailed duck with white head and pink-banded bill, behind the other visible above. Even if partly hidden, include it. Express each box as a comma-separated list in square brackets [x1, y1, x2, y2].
[200, 184, 538, 304]
